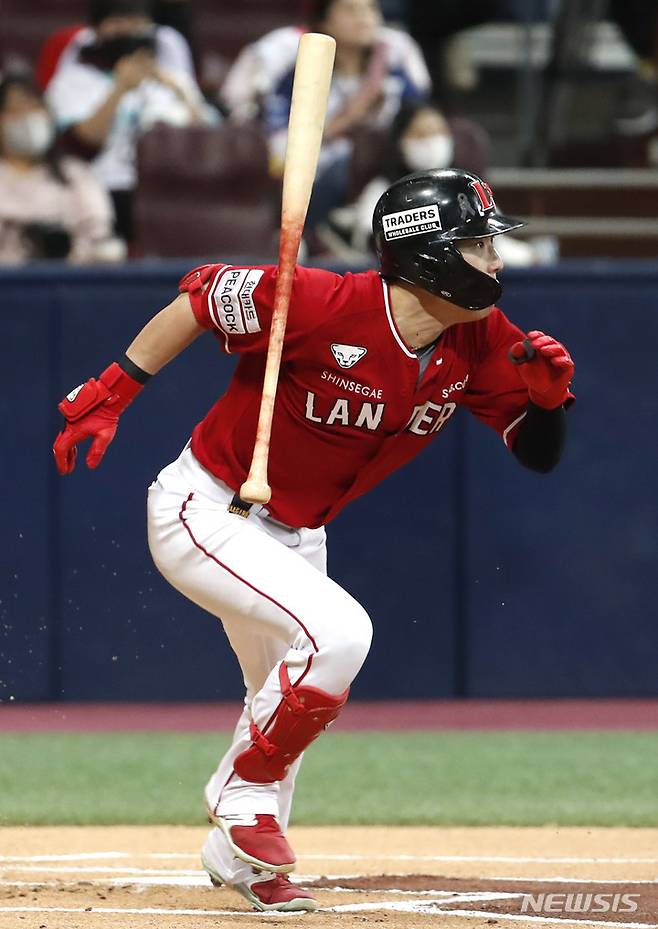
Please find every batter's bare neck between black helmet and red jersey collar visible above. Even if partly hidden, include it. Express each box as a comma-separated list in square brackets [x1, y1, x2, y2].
[389, 280, 490, 351]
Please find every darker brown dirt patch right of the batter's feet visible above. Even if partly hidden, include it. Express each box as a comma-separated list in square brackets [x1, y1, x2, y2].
[308, 874, 658, 929]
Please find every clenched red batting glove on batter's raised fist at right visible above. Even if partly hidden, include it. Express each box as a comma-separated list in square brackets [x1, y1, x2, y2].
[510, 329, 574, 410]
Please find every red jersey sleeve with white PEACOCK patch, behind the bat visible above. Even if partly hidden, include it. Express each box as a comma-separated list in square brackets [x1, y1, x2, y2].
[179, 264, 340, 355]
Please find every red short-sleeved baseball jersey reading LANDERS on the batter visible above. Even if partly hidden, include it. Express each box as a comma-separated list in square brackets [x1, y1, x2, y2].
[181, 265, 528, 528]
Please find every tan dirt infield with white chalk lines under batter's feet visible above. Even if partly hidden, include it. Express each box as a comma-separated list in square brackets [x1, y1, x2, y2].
[0, 826, 658, 929]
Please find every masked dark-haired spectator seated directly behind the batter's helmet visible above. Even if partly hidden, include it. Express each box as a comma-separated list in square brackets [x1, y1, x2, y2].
[317, 102, 557, 266]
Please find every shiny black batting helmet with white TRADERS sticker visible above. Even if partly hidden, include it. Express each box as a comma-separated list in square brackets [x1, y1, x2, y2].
[372, 168, 523, 310]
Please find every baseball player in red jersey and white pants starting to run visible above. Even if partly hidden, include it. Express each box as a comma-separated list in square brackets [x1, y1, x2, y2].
[54, 170, 574, 910]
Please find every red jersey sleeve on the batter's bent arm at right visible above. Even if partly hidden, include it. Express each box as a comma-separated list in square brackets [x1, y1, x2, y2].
[462, 309, 528, 449]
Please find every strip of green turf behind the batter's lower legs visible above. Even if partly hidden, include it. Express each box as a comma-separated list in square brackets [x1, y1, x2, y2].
[0, 732, 658, 826]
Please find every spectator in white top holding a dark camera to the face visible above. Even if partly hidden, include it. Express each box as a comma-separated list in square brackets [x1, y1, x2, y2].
[47, 0, 218, 242]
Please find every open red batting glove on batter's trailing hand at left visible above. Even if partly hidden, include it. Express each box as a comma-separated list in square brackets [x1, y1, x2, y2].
[53, 362, 144, 474]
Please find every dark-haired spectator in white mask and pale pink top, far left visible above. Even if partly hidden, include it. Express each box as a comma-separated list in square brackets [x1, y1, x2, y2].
[0, 75, 120, 264]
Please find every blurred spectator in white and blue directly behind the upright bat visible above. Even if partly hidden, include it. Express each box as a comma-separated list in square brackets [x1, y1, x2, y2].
[221, 0, 431, 236]
